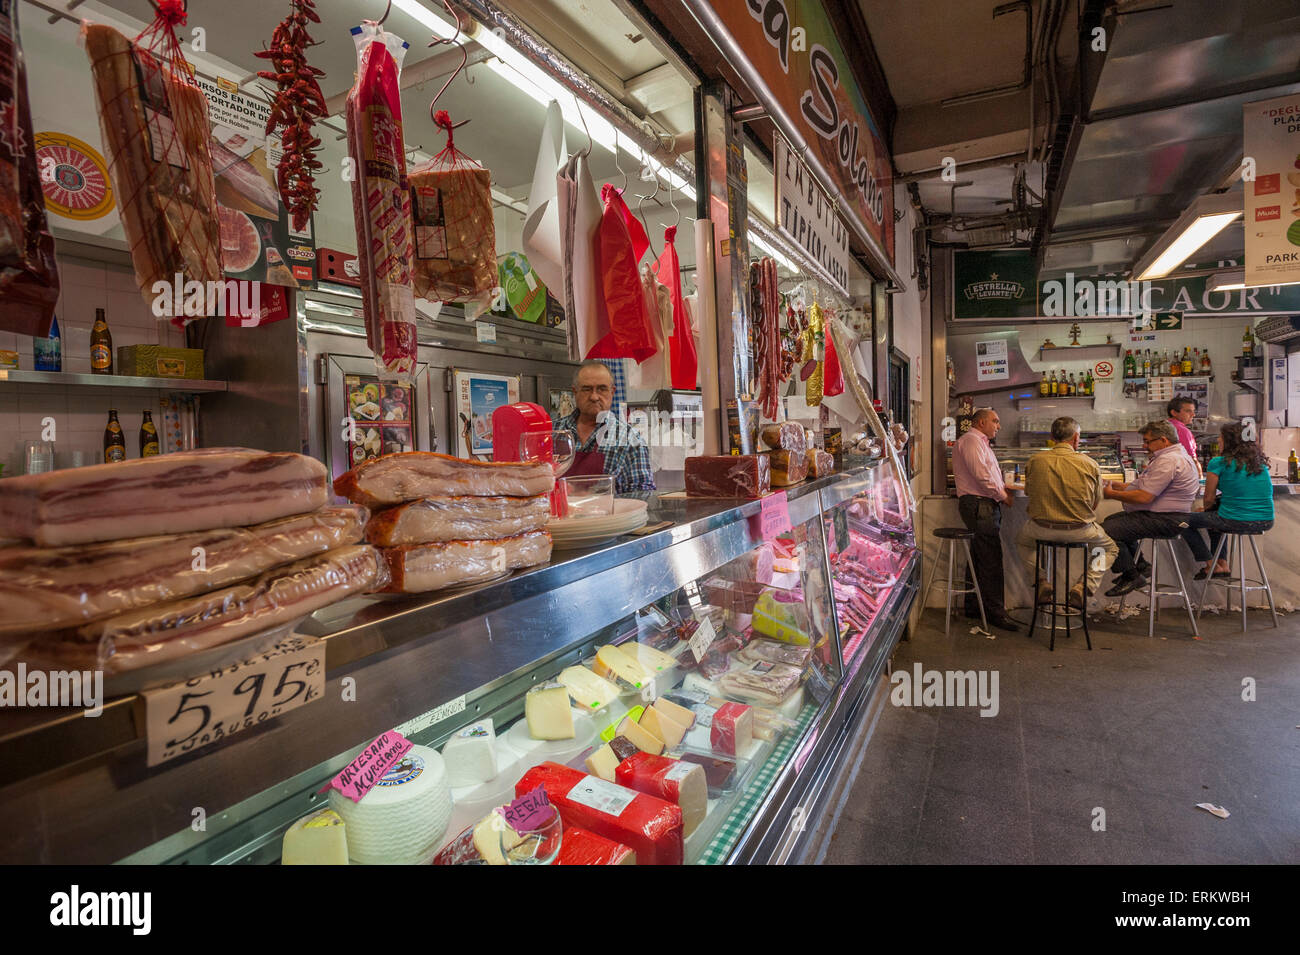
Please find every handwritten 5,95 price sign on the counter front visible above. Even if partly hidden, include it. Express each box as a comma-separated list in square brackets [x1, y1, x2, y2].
[143, 637, 325, 767]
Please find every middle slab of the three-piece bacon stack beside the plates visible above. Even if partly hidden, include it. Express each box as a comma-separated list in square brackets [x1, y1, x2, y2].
[365, 494, 551, 547]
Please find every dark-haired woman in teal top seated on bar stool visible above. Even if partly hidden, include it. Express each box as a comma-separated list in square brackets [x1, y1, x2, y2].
[1190, 421, 1273, 581]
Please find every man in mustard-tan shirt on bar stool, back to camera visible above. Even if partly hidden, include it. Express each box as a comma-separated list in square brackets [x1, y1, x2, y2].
[1017, 417, 1118, 609]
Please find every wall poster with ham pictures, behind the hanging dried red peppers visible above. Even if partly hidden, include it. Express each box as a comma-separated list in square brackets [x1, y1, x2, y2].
[194, 75, 316, 288]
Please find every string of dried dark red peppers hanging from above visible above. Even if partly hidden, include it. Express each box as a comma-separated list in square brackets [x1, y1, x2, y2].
[256, 0, 325, 230]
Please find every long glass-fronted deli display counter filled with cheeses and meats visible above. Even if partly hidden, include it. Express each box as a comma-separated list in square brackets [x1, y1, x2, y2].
[0, 468, 917, 864]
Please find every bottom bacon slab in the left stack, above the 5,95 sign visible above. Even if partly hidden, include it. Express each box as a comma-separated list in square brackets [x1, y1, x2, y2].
[23, 544, 387, 673]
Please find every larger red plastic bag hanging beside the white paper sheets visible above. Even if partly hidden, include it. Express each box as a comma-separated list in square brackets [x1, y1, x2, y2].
[584, 183, 657, 363]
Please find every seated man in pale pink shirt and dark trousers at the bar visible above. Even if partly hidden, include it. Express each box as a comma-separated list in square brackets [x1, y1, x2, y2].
[1101, 421, 1210, 596]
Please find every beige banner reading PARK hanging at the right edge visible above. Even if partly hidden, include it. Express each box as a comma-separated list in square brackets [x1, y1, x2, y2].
[1242, 94, 1300, 286]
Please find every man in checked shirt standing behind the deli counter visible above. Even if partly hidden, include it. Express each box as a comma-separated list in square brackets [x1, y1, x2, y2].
[555, 361, 655, 494]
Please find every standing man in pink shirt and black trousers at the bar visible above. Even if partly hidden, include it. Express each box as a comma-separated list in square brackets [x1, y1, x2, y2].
[953, 408, 1021, 630]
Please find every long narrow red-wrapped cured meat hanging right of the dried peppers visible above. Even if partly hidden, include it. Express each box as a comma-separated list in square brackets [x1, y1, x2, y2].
[343, 19, 417, 381]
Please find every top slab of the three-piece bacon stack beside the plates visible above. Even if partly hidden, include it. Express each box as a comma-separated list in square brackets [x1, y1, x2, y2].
[334, 451, 555, 508]
